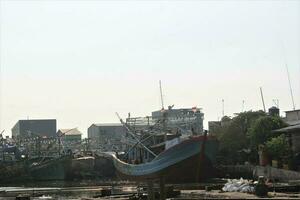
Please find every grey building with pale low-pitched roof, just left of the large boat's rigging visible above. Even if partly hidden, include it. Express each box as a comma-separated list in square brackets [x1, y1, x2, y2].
[88, 123, 126, 151]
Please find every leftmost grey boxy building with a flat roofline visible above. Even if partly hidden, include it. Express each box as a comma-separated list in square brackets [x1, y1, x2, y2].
[11, 119, 56, 138]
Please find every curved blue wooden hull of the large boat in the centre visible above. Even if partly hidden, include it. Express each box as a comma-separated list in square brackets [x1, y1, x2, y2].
[111, 135, 218, 183]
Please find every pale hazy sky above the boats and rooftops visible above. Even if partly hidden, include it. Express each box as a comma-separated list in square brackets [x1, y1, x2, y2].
[0, 0, 300, 136]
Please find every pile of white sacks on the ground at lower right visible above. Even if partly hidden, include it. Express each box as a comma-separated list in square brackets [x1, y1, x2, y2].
[222, 178, 254, 193]
